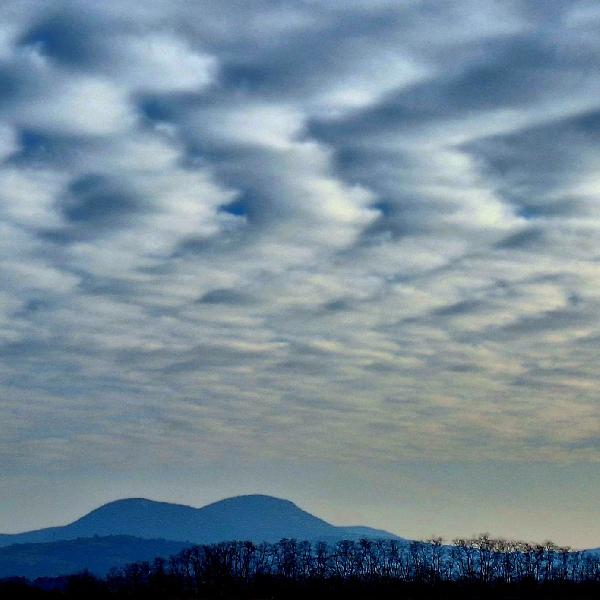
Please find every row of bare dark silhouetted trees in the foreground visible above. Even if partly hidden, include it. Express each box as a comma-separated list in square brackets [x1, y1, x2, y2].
[110, 534, 600, 589]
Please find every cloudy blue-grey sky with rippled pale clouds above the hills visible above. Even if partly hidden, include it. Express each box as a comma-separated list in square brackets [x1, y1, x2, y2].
[0, 0, 600, 547]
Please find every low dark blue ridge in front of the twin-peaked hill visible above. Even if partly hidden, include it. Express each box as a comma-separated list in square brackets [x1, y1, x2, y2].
[0, 535, 189, 579]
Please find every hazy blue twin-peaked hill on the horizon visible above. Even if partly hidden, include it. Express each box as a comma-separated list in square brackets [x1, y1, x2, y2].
[0, 495, 401, 547]
